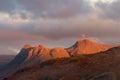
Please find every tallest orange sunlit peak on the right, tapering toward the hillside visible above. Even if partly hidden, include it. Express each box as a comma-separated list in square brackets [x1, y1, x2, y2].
[67, 39, 113, 55]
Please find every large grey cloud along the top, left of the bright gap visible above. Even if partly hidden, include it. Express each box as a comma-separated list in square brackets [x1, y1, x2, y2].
[17, 0, 92, 18]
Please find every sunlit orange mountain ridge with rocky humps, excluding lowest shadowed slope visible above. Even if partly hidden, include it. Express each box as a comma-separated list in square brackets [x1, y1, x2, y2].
[8, 39, 113, 66]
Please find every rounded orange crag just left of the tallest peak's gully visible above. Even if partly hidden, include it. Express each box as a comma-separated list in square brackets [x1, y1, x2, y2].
[50, 48, 70, 58]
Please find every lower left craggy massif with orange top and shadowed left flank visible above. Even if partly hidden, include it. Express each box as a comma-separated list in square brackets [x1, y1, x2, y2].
[12, 45, 70, 66]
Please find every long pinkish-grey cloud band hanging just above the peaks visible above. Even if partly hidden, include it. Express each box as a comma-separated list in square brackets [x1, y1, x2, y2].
[19, 17, 120, 40]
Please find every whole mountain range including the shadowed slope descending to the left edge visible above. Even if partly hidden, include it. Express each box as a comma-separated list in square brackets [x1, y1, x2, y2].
[0, 39, 116, 80]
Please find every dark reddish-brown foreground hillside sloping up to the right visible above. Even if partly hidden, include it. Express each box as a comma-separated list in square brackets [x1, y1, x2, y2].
[4, 47, 120, 80]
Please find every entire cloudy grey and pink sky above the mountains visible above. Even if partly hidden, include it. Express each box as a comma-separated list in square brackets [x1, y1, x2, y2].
[0, 0, 120, 54]
